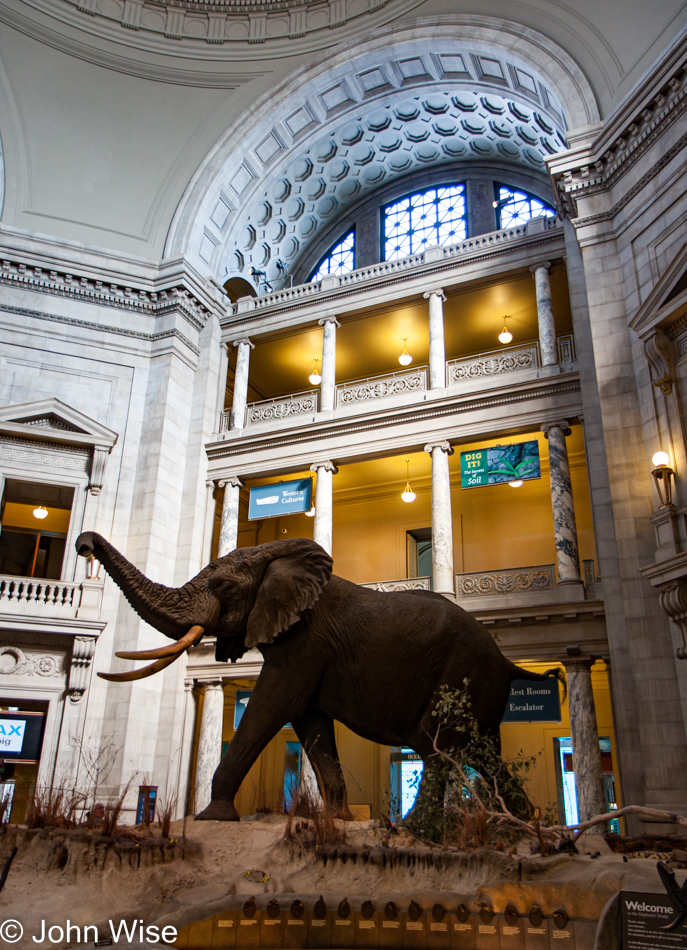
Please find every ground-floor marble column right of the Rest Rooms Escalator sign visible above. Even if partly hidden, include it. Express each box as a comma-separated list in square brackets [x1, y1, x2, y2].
[563, 656, 606, 834]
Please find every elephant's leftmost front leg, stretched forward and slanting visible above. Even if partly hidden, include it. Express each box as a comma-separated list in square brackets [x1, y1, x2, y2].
[196, 666, 310, 821]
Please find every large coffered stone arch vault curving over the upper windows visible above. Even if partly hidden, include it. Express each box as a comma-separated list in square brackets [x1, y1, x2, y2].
[166, 16, 598, 282]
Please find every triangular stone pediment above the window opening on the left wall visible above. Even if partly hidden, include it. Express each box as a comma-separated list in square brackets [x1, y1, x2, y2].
[0, 398, 117, 452]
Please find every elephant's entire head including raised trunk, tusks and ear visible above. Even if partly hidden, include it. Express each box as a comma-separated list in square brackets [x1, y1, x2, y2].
[76, 531, 332, 682]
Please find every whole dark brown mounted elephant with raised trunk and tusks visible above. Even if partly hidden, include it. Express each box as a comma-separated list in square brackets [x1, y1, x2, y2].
[76, 532, 558, 821]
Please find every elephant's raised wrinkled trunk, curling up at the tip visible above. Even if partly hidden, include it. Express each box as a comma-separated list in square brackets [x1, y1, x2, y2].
[76, 531, 220, 640]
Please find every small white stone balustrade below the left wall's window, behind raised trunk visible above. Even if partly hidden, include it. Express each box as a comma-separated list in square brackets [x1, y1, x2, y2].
[0, 574, 103, 619]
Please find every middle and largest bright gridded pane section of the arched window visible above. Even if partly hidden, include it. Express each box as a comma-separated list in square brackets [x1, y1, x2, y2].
[382, 184, 467, 261]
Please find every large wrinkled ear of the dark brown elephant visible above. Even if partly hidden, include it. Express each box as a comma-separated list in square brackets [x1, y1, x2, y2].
[246, 538, 333, 649]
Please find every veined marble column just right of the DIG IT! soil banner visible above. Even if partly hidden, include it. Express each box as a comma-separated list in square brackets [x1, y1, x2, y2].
[541, 420, 582, 584]
